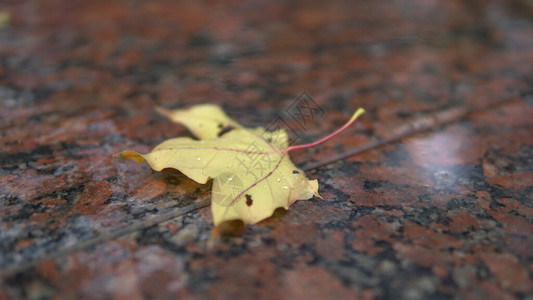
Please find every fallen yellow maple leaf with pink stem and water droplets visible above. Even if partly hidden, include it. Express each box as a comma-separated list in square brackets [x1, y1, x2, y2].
[117, 105, 364, 227]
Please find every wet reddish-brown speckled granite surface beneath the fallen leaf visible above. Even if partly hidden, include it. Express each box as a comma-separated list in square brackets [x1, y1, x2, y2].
[0, 0, 533, 299]
